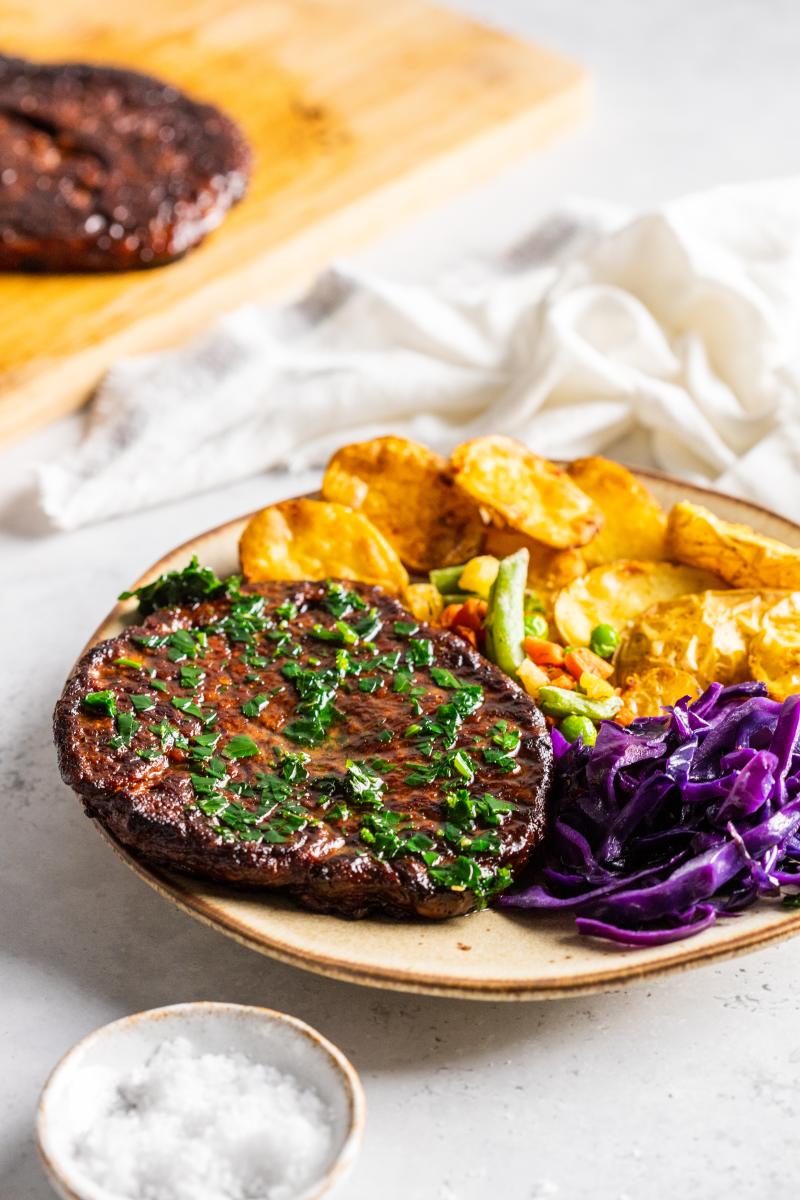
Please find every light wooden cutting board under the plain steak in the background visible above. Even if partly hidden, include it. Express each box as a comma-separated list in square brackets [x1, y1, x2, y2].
[0, 0, 588, 442]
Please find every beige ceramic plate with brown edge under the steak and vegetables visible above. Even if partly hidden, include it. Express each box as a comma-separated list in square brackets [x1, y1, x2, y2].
[79, 474, 800, 1000]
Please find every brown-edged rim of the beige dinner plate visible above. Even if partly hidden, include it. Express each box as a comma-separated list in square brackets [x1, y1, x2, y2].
[82, 469, 800, 1001]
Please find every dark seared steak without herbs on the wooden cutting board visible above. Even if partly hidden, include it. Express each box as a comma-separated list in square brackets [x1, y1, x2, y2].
[0, 55, 251, 271]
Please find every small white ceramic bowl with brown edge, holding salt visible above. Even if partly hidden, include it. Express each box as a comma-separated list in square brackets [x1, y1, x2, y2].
[36, 1002, 366, 1200]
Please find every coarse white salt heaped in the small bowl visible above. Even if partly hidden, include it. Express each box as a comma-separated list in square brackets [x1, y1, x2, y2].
[66, 1037, 332, 1200]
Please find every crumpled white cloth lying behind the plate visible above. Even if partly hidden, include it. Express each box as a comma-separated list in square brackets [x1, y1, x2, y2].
[40, 179, 800, 529]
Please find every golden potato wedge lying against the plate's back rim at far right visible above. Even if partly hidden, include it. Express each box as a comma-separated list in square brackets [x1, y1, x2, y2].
[667, 502, 800, 589]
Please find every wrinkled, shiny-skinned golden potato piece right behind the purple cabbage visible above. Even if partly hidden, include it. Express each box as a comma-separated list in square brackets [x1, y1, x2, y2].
[615, 588, 787, 689]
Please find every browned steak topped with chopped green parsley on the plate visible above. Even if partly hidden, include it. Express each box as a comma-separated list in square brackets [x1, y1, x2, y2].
[55, 563, 552, 918]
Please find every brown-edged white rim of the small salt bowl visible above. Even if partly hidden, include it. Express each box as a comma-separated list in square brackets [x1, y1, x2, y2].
[36, 1000, 367, 1200]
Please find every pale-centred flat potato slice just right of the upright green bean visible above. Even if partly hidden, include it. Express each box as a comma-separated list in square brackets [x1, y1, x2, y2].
[553, 559, 720, 646]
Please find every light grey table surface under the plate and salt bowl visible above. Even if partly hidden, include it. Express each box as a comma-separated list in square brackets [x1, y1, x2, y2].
[0, 0, 800, 1200]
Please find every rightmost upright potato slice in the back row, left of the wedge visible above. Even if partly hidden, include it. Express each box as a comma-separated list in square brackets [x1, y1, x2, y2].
[567, 456, 667, 566]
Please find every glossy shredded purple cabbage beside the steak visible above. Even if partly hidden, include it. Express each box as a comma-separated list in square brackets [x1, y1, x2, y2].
[500, 683, 800, 947]
